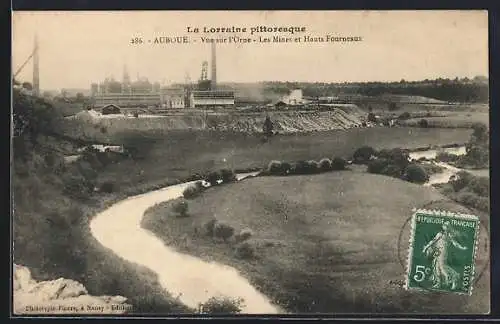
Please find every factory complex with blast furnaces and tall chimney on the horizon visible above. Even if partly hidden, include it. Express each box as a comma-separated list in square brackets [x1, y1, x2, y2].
[91, 43, 234, 111]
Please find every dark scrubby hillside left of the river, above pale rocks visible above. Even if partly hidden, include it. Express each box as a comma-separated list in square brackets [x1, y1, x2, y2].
[12, 91, 191, 312]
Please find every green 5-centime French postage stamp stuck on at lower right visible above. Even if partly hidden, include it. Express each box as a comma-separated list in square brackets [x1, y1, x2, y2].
[406, 210, 479, 295]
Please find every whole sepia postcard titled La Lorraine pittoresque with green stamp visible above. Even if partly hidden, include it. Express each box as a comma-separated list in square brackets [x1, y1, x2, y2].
[11, 10, 490, 317]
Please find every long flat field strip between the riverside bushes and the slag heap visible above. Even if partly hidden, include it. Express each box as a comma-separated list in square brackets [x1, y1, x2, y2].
[94, 127, 471, 191]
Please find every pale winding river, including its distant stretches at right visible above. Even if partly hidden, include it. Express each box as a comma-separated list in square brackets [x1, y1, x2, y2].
[90, 148, 472, 314]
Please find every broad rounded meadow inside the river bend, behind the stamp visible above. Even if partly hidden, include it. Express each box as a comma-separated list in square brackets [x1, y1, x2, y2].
[142, 171, 489, 313]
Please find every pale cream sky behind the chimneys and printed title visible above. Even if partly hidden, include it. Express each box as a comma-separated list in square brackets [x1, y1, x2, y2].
[12, 10, 488, 90]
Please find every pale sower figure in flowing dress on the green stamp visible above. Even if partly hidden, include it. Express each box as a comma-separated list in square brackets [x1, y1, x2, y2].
[422, 222, 467, 289]
